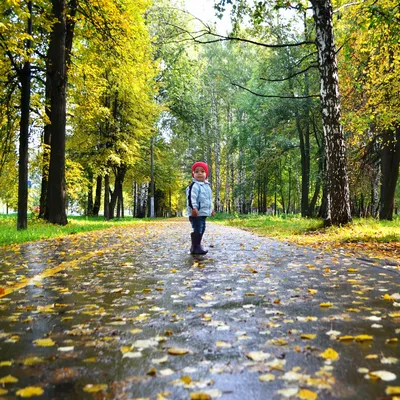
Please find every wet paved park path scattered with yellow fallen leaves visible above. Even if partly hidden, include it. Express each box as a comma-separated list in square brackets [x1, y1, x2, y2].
[0, 219, 400, 400]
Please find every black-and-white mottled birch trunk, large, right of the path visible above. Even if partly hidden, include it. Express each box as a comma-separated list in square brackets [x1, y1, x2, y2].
[311, 0, 351, 225]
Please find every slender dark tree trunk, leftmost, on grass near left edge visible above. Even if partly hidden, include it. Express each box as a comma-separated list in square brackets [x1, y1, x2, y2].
[17, 1, 32, 230]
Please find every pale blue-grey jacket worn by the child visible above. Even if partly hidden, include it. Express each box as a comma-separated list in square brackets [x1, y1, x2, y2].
[186, 178, 213, 217]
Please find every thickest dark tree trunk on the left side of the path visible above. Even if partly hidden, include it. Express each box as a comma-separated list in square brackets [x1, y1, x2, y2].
[47, 0, 67, 225]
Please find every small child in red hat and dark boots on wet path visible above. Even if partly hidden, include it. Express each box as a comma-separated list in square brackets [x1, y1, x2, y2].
[186, 161, 214, 254]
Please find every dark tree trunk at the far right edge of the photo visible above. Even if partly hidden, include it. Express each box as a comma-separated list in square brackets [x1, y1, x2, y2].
[379, 126, 400, 221]
